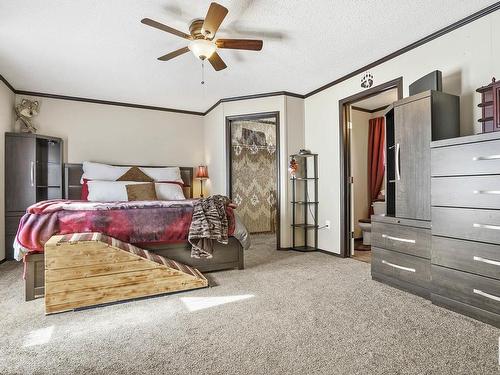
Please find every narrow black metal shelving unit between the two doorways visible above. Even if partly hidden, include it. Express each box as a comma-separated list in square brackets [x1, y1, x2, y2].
[290, 154, 319, 252]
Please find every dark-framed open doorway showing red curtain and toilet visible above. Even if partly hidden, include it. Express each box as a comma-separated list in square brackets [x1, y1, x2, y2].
[339, 78, 403, 263]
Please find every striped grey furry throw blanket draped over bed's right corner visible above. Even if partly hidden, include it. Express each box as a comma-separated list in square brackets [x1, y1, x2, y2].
[188, 195, 230, 259]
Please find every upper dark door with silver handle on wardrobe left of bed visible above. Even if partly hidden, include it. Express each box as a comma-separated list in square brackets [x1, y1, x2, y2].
[5, 136, 36, 212]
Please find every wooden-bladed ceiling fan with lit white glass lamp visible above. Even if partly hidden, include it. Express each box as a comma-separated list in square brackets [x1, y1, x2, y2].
[141, 3, 262, 71]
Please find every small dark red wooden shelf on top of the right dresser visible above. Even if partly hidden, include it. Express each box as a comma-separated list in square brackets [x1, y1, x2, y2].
[476, 77, 500, 133]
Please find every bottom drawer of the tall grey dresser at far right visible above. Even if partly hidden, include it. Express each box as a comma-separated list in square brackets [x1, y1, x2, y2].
[432, 265, 500, 314]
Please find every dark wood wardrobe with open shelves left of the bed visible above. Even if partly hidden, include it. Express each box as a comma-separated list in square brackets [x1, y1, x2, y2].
[5, 133, 63, 259]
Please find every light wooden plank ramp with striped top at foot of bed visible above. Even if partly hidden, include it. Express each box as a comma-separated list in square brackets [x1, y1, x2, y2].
[44, 233, 208, 314]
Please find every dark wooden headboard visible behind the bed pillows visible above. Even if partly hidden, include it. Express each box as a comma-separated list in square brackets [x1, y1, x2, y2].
[64, 163, 194, 200]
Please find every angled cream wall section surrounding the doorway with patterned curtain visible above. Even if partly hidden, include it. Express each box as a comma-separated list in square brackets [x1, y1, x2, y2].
[204, 95, 305, 247]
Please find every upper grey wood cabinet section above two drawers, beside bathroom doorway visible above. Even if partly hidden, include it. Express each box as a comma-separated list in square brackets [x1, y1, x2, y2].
[387, 91, 460, 221]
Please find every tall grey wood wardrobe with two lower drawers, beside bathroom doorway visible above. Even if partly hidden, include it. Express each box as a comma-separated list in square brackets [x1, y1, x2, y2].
[372, 91, 460, 298]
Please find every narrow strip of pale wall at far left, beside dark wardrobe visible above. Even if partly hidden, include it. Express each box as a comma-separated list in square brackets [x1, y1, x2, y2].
[0, 81, 15, 261]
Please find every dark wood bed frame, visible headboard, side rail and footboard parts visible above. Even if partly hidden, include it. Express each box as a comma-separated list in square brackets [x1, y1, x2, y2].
[24, 163, 244, 301]
